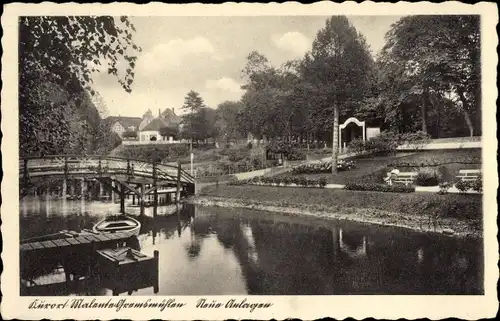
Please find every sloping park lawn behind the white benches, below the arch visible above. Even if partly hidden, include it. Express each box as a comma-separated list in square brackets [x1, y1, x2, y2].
[280, 149, 481, 184]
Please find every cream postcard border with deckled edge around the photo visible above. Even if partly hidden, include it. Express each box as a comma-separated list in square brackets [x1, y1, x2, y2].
[1, 2, 498, 320]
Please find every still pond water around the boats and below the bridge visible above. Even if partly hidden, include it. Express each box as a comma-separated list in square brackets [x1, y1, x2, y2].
[20, 197, 483, 295]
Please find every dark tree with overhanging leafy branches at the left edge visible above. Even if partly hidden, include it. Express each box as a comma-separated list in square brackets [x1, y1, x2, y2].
[19, 16, 140, 154]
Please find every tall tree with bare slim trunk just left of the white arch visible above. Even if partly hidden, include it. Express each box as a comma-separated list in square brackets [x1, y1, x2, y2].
[301, 16, 373, 172]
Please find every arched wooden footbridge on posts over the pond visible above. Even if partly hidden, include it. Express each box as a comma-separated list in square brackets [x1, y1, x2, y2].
[19, 155, 195, 213]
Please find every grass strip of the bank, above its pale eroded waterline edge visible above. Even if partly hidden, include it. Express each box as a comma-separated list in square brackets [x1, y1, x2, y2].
[200, 185, 482, 222]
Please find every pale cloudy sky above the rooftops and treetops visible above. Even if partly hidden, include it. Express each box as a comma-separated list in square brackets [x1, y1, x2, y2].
[93, 16, 401, 117]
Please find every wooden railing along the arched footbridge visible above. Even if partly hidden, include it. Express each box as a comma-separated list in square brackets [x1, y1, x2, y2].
[19, 155, 195, 183]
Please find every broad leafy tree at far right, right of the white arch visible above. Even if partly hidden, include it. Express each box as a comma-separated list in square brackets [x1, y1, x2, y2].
[379, 15, 481, 136]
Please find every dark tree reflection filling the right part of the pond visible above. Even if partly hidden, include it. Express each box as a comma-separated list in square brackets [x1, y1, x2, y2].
[186, 207, 482, 294]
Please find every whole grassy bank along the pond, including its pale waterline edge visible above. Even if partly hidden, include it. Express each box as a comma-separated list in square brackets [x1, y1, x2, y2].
[195, 185, 482, 237]
